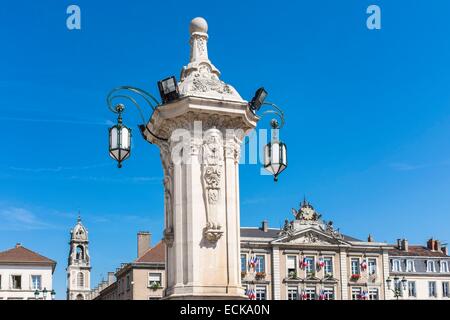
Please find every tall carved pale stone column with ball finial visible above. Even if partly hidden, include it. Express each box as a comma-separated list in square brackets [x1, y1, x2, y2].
[144, 18, 258, 299]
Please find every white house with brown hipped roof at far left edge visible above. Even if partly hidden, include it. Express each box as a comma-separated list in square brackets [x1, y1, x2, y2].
[0, 243, 56, 300]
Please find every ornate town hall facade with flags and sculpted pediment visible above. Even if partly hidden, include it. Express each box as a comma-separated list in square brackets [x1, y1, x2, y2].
[241, 200, 391, 300]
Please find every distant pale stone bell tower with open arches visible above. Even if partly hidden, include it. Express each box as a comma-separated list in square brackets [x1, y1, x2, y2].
[66, 216, 91, 300]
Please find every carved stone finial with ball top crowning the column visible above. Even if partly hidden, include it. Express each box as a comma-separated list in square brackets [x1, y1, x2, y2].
[178, 17, 244, 102]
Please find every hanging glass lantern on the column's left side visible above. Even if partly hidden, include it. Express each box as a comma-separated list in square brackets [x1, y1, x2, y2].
[109, 104, 131, 168]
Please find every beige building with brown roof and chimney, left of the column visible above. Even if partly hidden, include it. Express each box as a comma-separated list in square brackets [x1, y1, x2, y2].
[92, 232, 166, 300]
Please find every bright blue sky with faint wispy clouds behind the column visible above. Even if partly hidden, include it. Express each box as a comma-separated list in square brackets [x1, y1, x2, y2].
[0, 0, 450, 299]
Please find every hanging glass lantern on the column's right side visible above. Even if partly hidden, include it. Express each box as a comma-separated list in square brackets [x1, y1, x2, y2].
[264, 120, 287, 182]
